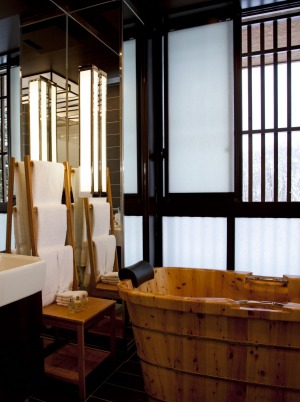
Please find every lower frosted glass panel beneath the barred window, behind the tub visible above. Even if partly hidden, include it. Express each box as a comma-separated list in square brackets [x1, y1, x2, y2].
[235, 218, 300, 276]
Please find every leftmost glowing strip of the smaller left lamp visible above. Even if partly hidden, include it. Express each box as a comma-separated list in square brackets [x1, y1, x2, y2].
[29, 80, 40, 160]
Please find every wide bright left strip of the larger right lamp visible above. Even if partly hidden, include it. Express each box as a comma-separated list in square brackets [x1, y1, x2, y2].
[79, 70, 92, 197]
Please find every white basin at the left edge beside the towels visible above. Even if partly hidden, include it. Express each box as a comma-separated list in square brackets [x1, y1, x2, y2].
[0, 253, 46, 307]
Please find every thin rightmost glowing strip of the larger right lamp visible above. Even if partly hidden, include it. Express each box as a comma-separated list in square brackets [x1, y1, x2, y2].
[99, 71, 107, 192]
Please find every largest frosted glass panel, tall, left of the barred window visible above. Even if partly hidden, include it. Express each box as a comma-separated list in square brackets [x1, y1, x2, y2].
[168, 21, 233, 193]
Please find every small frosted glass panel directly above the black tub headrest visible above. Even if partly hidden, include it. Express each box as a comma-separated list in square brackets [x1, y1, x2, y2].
[123, 216, 143, 266]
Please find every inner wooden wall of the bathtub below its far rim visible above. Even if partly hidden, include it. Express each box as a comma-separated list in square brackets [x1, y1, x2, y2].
[139, 268, 300, 303]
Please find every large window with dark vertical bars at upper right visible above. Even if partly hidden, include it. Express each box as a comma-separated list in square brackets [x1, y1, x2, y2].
[242, 12, 300, 202]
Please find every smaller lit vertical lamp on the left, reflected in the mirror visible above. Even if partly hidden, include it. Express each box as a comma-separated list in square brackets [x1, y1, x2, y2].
[29, 77, 57, 162]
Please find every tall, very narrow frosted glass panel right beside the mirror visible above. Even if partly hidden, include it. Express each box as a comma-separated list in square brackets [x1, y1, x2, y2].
[123, 40, 137, 194]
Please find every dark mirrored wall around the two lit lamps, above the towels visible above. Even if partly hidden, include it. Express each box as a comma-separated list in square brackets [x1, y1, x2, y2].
[21, 0, 121, 208]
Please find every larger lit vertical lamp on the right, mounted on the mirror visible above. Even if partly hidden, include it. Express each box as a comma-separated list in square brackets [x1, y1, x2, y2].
[79, 65, 107, 197]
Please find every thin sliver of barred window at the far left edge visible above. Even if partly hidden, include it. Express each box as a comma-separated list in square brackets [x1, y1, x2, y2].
[0, 65, 8, 206]
